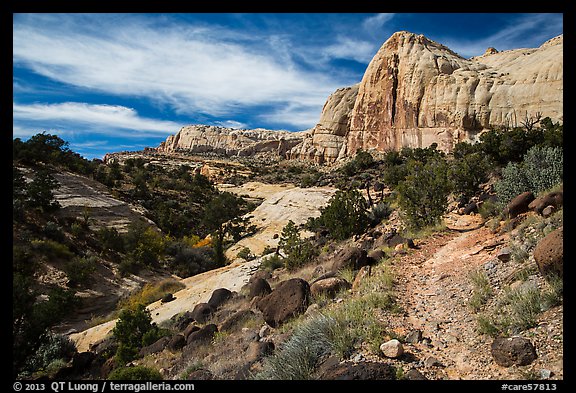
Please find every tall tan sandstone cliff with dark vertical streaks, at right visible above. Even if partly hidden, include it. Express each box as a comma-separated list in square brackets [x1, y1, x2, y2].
[290, 31, 563, 162]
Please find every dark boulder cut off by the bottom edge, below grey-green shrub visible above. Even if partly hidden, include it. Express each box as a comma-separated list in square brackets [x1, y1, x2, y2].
[320, 362, 396, 380]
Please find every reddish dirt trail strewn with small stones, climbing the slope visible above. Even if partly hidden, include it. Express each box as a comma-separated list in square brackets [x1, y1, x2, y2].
[388, 219, 562, 380]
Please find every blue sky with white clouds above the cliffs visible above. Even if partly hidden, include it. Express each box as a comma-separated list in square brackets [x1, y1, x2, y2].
[13, 13, 563, 159]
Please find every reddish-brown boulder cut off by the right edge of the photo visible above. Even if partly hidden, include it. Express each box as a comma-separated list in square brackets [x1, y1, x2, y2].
[534, 226, 564, 277]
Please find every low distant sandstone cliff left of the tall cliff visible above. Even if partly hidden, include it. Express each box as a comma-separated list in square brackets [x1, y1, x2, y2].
[157, 125, 306, 157]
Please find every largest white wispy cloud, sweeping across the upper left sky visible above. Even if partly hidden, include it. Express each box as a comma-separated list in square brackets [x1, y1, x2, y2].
[13, 15, 341, 129]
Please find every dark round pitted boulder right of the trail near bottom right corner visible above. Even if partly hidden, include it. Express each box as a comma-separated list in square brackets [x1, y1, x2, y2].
[490, 336, 537, 367]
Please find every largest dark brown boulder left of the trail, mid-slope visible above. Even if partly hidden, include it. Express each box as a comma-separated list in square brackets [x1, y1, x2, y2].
[257, 278, 310, 327]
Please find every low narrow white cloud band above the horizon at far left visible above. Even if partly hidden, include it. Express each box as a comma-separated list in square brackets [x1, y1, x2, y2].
[12, 102, 182, 137]
